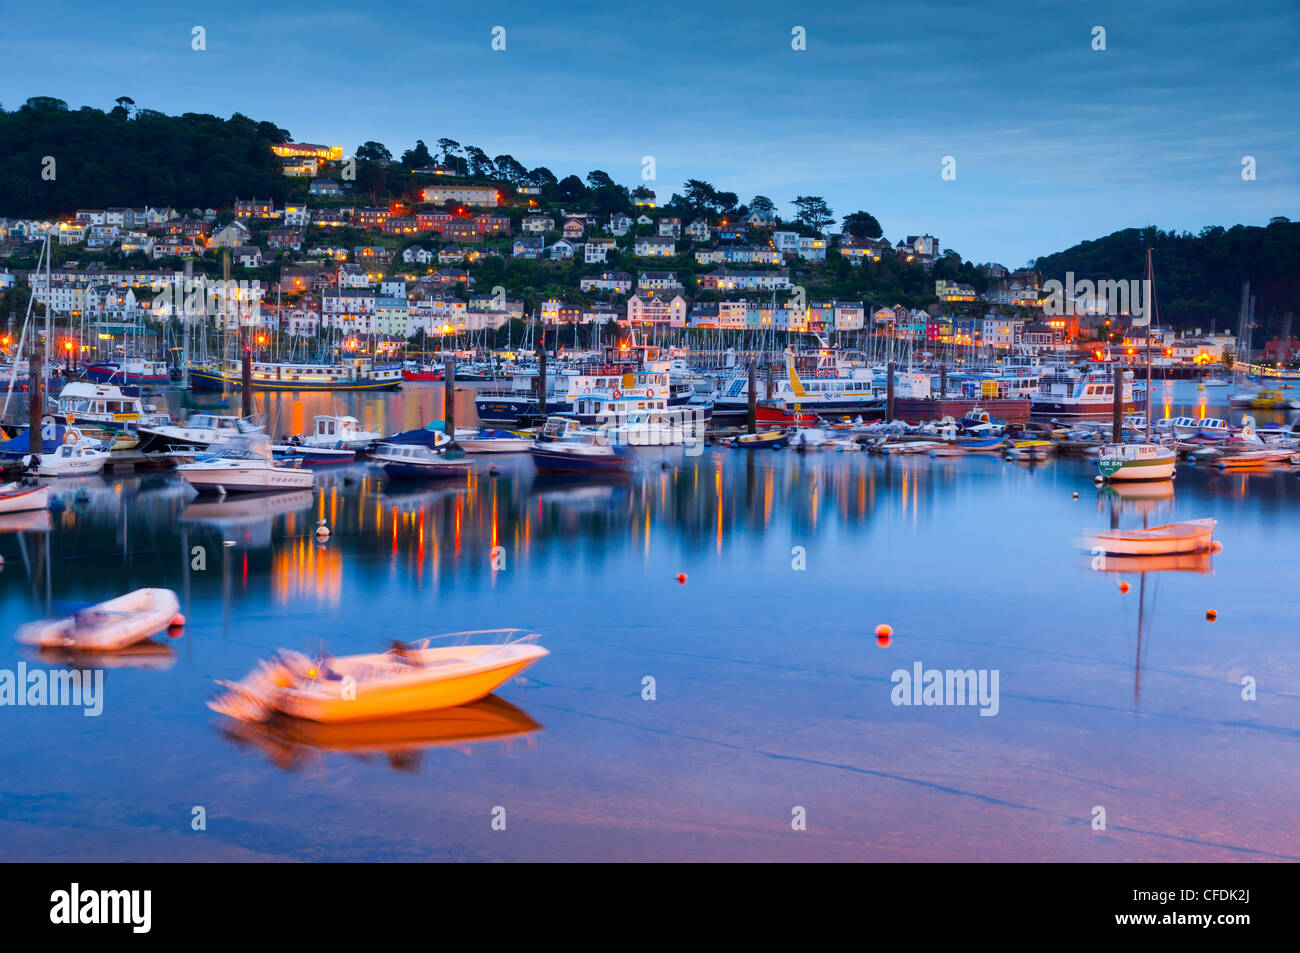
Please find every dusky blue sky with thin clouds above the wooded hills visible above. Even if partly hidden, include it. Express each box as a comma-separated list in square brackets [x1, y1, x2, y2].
[0, 0, 1300, 268]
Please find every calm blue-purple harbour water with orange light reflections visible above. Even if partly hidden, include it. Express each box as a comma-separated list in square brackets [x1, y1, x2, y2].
[0, 385, 1300, 861]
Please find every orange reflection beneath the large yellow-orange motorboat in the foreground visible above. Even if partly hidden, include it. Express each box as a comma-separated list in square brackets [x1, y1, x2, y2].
[221, 696, 543, 771]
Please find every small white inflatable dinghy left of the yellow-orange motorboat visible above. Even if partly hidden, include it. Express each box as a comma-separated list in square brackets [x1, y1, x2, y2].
[17, 589, 183, 651]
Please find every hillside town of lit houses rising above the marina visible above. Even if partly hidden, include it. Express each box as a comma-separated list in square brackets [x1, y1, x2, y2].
[0, 137, 1232, 365]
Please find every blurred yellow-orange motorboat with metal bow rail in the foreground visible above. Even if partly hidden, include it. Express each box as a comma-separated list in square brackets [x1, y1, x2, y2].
[208, 629, 550, 724]
